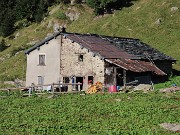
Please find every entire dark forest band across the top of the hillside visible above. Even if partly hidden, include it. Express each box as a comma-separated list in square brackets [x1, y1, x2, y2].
[0, 0, 135, 37]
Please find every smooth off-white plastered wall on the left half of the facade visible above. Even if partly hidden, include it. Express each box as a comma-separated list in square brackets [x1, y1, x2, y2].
[26, 36, 61, 86]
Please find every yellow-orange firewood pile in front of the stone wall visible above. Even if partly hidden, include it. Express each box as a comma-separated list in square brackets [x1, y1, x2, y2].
[86, 82, 102, 94]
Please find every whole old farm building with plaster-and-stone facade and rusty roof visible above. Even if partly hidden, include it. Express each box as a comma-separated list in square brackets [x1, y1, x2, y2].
[25, 32, 176, 90]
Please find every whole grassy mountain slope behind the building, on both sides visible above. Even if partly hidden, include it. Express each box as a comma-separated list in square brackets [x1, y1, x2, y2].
[0, 0, 180, 81]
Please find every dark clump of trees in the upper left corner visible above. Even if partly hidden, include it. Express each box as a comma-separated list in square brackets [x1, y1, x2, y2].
[0, 0, 49, 37]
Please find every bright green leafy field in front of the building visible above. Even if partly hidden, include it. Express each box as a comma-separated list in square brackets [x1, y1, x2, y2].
[0, 92, 180, 135]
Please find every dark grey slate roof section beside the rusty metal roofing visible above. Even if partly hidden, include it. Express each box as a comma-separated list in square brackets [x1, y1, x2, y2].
[103, 36, 176, 62]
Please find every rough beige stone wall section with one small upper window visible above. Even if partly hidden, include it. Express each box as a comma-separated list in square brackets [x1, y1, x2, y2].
[60, 37, 104, 90]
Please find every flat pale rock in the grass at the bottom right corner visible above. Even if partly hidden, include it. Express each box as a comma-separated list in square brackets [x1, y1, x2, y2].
[160, 123, 180, 132]
